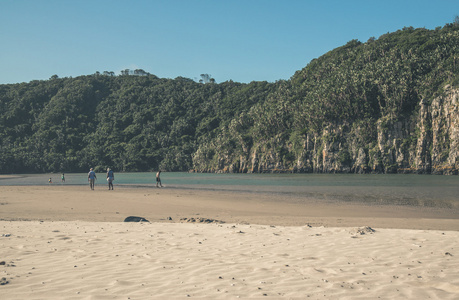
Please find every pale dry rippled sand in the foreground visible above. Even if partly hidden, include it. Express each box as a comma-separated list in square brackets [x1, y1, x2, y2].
[0, 221, 459, 299]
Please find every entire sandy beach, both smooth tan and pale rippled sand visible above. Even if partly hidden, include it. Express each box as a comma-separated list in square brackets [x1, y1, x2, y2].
[0, 185, 459, 299]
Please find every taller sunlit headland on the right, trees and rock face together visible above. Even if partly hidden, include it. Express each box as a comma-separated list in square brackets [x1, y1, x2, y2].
[193, 24, 459, 174]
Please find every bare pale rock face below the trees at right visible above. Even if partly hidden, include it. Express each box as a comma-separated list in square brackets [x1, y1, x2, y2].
[193, 86, 459, 174]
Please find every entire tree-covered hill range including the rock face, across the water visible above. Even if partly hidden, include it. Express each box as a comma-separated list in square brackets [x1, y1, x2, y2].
[0, 24, 459, 174]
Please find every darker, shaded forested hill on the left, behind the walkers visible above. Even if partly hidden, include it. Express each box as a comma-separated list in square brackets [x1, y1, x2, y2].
[0, 74, 275, 173]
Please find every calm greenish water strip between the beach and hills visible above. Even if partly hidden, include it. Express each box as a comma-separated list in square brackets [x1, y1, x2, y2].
[0, 172, 459, 209]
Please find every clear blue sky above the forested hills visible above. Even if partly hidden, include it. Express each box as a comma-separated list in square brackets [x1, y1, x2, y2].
[0, 0, 459, 84]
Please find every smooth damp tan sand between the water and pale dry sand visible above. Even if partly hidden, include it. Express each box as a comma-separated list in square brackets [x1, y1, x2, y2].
[0, 185, 459, 231]
